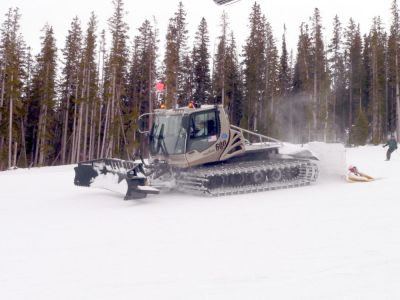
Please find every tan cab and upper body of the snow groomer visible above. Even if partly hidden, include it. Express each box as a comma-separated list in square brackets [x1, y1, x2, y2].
[148, 105, 281, 168]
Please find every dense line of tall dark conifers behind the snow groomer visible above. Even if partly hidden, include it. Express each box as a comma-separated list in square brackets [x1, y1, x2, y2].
[0, 0, 400, 170]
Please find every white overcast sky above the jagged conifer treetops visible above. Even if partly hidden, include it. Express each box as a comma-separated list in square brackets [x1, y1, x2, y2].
[0, 0, 392, 55]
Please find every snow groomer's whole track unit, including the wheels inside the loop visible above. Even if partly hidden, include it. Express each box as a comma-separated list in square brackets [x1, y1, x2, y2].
[176, 159, 318, 196]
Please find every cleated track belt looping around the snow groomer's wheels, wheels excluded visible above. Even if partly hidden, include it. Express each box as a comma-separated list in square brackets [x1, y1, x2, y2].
[176, 159, 318, 196]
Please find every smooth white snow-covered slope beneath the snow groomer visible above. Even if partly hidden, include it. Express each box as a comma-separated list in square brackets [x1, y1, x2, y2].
[0, 146, 400, 300]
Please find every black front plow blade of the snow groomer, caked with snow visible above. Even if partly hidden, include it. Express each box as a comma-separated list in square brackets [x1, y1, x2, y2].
[74, 158, 160, 200]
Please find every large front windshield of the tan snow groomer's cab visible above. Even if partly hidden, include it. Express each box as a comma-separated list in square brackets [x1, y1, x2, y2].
[150, 115, 186, 155]
